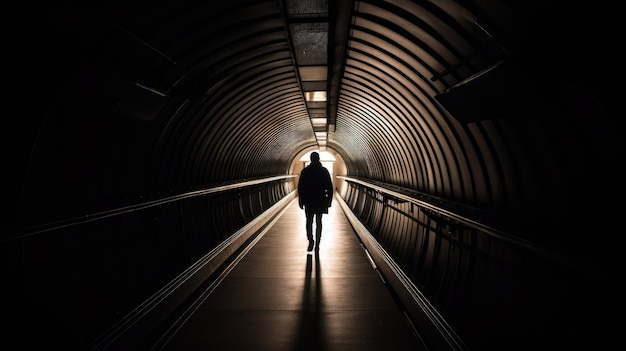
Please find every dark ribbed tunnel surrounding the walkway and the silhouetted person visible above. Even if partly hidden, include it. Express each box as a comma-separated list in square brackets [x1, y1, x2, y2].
[0, 0, 622, 350]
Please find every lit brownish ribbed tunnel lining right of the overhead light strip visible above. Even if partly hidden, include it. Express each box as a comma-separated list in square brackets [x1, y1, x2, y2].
[335, 1, 512, 204]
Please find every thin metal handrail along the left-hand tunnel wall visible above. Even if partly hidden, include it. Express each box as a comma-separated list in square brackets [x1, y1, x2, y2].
[0, 175, 297, 243]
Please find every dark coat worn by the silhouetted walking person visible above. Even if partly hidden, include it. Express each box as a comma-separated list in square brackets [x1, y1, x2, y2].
[298, 162, 333, 213]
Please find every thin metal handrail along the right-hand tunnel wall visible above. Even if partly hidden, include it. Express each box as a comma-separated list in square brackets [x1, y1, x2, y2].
[337, 176, 580, 268]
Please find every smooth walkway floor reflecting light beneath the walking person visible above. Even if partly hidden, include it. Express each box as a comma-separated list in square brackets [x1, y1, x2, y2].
[158, 200, 426, 351]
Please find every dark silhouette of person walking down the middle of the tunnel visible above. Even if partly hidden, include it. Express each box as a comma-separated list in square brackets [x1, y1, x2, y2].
[298, 151, 333, 251]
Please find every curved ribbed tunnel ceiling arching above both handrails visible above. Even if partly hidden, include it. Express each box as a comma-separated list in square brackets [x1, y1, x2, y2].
[9, 0, 614, 236]
